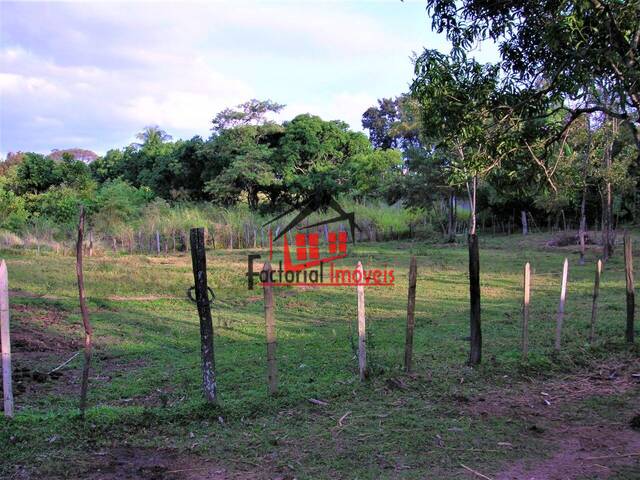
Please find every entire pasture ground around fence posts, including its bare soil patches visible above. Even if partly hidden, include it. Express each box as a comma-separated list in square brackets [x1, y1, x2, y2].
[0, 235, 640, 479]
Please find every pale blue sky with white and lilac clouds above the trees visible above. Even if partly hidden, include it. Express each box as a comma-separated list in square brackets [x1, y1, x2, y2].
[0, 0, 497, 158]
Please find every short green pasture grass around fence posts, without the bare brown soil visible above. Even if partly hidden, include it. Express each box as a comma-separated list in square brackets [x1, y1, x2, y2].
[0, 231, 638, 478]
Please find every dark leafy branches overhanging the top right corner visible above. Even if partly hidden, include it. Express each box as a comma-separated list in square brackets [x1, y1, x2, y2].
[427, 0, 640, 149]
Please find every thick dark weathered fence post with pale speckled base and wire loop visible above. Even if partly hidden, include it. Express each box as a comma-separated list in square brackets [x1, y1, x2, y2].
[191, 228, 217, 403]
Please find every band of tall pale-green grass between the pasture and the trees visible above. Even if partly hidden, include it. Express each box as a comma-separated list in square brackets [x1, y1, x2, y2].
[0, 200, 464, 253]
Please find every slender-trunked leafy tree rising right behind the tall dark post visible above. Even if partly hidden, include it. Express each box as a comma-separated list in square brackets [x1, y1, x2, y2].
[411, 50, 507, 235]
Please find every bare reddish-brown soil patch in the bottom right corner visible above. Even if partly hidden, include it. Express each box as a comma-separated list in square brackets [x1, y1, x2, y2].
[462, 359, 640, 480]
